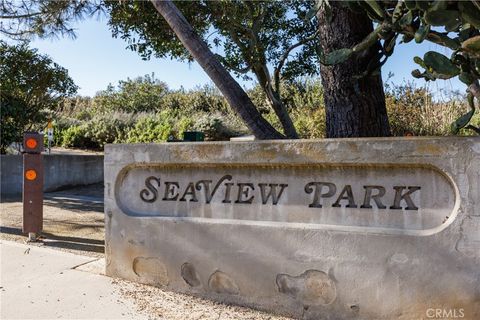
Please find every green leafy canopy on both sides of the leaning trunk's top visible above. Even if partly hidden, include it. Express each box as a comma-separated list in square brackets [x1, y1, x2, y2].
[105, 0, 318, 79]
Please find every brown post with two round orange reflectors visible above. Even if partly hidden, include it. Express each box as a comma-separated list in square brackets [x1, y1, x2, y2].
[23, 132, 44, 241]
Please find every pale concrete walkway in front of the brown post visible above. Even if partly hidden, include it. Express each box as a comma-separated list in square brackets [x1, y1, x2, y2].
[0, 241, 146, 319]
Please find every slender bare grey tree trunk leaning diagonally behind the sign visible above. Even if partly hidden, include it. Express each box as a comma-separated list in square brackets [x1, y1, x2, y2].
[152, 0, 284, 139]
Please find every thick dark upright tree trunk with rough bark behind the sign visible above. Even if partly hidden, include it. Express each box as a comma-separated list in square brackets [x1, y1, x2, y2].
[317, 1, 390, 138]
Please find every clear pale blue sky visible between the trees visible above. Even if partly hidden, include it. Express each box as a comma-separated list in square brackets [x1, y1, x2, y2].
[26, 18, 465, 99]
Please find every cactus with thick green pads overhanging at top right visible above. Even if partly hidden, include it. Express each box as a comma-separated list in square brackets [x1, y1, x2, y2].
[318, 0, 480, 133]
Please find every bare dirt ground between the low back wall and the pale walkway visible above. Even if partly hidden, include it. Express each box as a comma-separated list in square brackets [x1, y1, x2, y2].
[0, 185, 105, 258]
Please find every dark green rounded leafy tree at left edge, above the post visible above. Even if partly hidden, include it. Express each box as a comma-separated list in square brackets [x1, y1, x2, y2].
[0, 41, 77, 153]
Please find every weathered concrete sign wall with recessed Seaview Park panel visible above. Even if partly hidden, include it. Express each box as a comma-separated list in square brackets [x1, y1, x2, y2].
[105, 138, 480, 319]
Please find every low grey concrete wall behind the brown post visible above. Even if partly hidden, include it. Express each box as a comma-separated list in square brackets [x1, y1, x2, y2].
[0, 154, 103, 196]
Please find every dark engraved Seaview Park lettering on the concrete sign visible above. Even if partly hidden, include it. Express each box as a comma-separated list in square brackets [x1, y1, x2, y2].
[140, 174, 421, 210]
